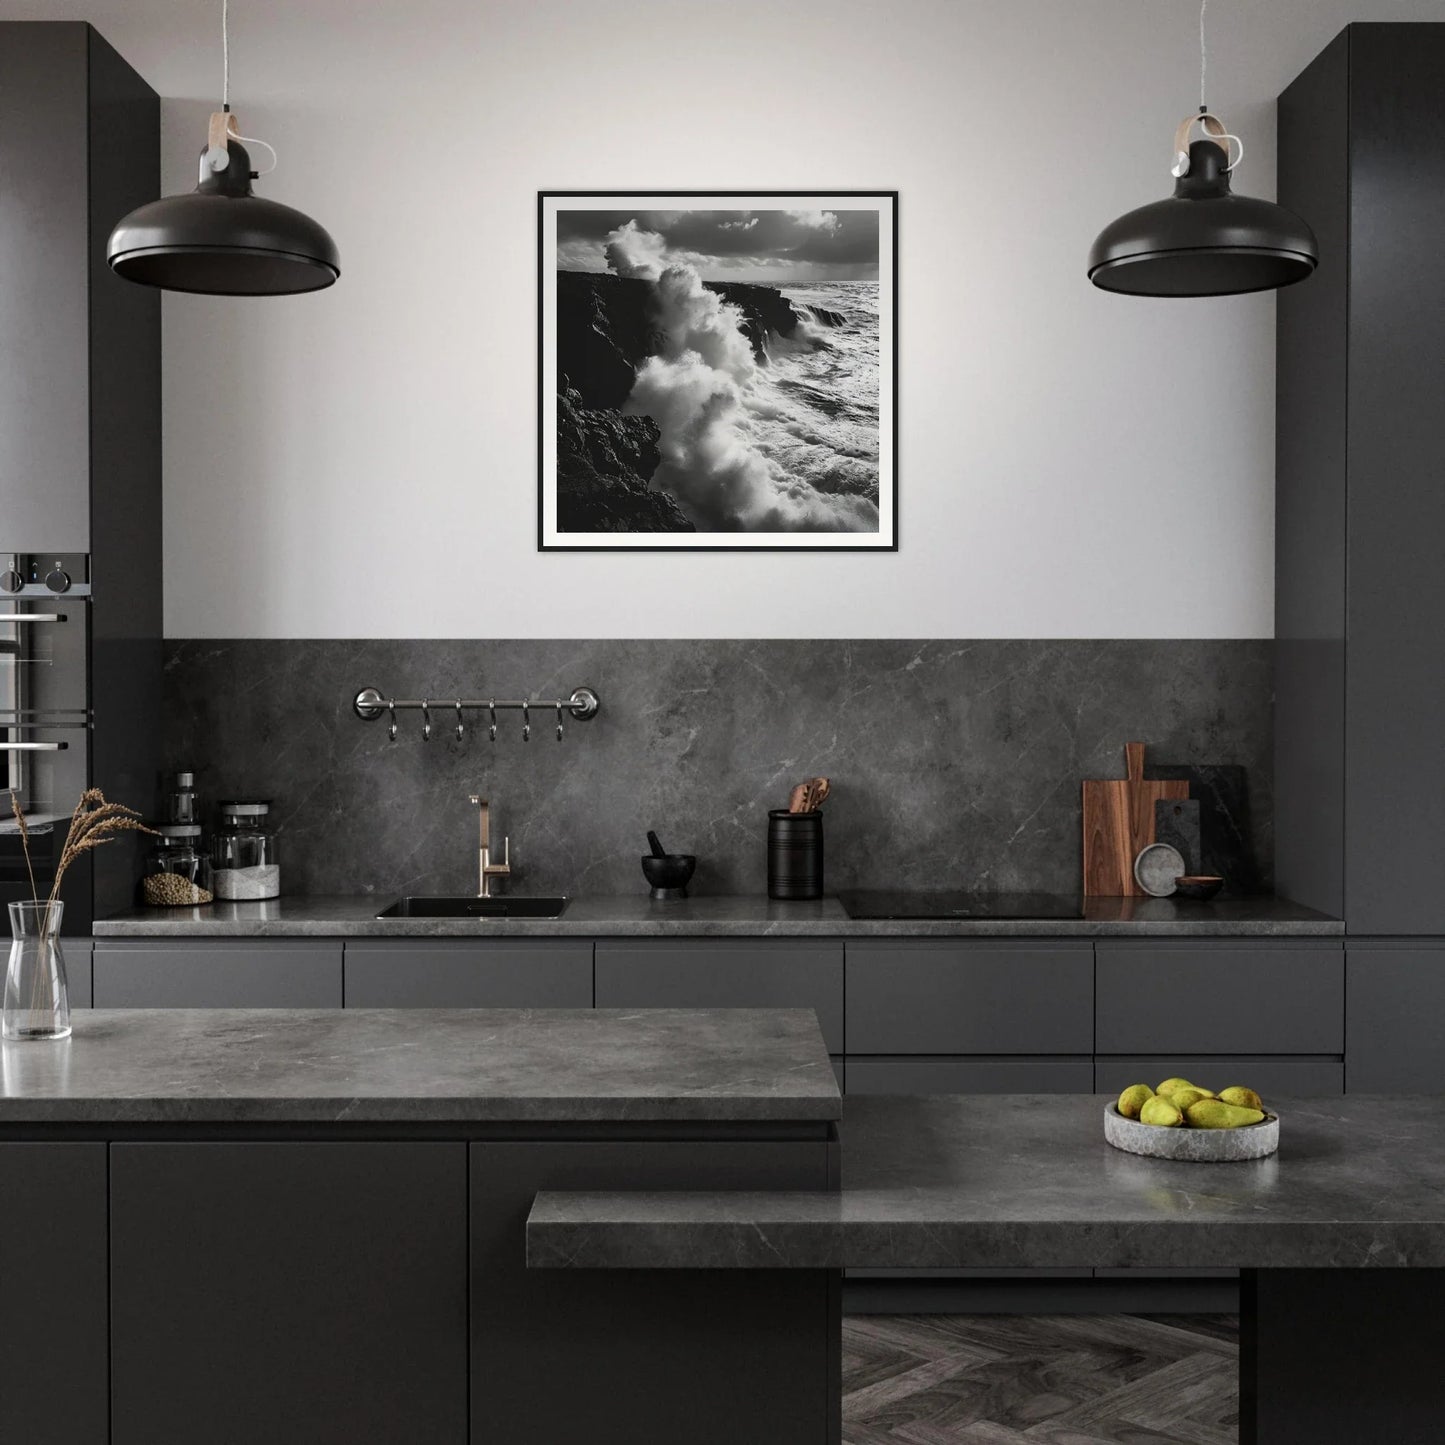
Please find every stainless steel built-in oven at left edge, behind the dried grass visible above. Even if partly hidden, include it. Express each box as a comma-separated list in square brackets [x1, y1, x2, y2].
[0, 553, 91, 933]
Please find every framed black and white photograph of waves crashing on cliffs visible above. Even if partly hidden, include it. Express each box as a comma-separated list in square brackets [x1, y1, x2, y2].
[538, 191, 897, 551]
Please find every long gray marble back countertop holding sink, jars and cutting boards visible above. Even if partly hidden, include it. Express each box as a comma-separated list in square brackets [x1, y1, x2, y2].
[92, 894, 1344, 938]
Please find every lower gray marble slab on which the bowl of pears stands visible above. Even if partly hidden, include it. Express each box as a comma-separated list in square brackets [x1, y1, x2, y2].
[527, 1094, 1445, 1269]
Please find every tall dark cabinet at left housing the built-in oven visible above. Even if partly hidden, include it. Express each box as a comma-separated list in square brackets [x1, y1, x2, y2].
[0, 22, 162, 933]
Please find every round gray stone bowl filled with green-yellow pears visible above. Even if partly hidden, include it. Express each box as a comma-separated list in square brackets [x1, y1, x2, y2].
[1104, 1078, 1279, 1163]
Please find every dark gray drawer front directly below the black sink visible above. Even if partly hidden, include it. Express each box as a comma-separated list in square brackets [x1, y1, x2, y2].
[345, 939, 592, 1009]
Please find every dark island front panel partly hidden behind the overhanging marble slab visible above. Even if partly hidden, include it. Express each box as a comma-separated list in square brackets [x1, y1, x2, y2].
[473, 1140, 842, 1445]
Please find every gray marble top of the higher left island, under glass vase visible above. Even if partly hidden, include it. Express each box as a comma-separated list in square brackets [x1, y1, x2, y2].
[0, 1009, 842, 1127]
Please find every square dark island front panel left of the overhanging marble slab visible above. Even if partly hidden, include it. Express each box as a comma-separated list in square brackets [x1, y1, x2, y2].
[111, 1143, 467, 1445]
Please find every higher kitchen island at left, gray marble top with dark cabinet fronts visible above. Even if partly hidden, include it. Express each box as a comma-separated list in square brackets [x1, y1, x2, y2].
[0, 1009, 841, 1445]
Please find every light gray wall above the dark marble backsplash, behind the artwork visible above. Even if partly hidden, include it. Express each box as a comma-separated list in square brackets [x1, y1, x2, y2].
[0, 0, 1445, 637]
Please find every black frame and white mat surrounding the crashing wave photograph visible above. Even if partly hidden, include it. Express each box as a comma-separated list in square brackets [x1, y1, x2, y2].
[538, 189, 900, 553]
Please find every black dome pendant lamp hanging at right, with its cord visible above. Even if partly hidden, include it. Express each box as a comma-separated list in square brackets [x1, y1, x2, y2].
[1088, 0, 1319, 296]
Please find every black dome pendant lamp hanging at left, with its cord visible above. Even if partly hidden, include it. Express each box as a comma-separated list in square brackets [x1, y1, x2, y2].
[105, 0, 341, 296]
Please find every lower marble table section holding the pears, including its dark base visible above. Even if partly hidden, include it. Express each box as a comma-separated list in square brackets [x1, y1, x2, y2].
[527, 1095, 1445, 1445]
